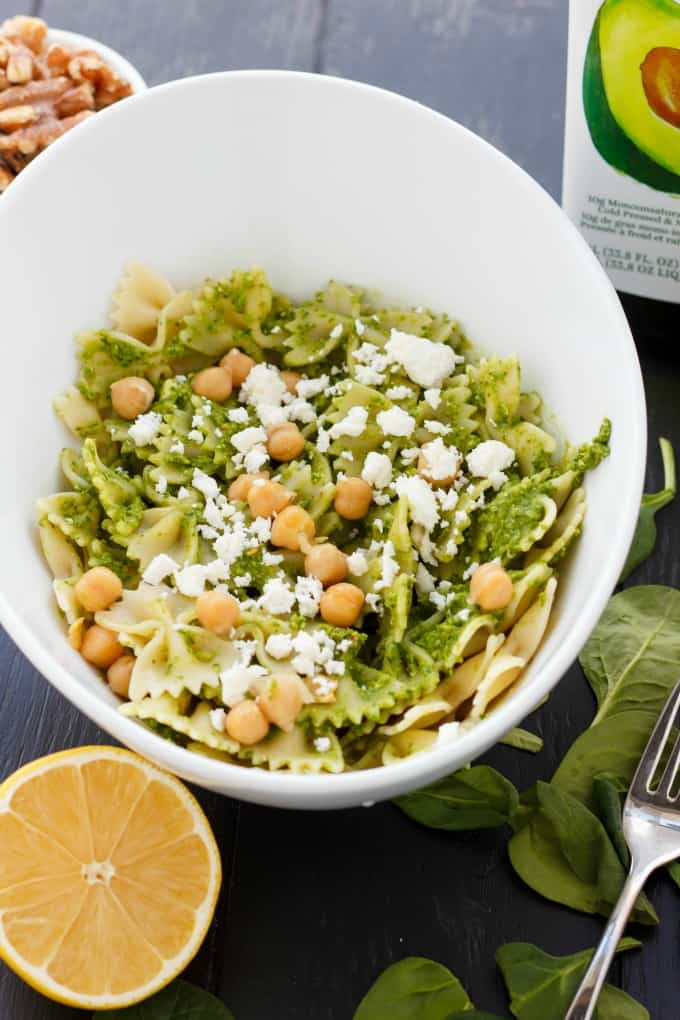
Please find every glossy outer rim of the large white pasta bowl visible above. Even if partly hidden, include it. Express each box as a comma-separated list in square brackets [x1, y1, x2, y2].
[0, 69, 647, 810]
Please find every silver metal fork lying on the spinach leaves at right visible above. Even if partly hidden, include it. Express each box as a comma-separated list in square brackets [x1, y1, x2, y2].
[565, 682, 680, 1020]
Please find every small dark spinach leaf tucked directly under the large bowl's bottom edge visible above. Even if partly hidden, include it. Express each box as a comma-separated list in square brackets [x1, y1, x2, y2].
[395, 765, 519, 831]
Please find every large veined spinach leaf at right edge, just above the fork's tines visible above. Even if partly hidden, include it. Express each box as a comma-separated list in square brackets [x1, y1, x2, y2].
[580, 584, 680, 736]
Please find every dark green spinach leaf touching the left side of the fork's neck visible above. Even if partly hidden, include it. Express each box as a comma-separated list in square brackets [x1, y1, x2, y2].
[508, 782, 659, 924]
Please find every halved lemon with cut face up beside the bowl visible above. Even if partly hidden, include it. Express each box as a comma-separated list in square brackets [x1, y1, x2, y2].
[0, 747, 221, 1010]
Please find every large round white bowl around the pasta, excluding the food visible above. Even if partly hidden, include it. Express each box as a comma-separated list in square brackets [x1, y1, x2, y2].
[0, 71, 645, 809]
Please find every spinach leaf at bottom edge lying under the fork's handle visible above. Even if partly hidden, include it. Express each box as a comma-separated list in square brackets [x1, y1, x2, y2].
[496, 938, 649, 1020]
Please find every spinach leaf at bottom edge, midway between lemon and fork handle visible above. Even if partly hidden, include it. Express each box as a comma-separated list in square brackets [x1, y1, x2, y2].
[354, 957, 472, 1020]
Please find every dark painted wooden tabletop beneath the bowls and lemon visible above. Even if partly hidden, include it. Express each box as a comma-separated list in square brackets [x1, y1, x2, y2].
[0, 0, 680, 1020]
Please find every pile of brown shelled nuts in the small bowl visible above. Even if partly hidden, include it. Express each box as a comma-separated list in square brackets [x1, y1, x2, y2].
[0, 16, 133, 193]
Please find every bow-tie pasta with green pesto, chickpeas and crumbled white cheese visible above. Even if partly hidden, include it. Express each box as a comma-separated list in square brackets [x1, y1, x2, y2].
[38, 263, 611, 772]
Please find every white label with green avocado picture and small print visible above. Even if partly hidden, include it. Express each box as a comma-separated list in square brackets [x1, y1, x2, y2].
[563, 0, 680, 302]
